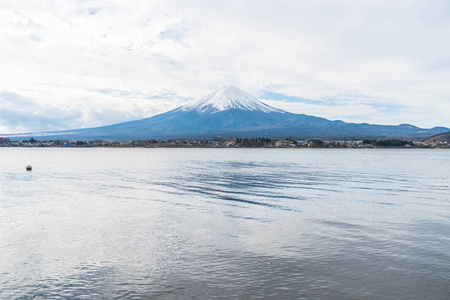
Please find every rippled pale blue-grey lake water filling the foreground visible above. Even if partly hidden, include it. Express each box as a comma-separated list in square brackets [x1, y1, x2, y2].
[0, 148, 450, 299]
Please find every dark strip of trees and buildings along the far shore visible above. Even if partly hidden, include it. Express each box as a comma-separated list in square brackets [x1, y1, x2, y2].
[0, 137, 450, 148]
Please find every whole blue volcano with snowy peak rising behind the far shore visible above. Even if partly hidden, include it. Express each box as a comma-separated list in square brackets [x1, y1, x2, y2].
[5, 86, 449, 140]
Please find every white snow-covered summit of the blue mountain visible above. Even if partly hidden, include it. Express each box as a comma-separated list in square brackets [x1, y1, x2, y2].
[179, 86, 284, 114]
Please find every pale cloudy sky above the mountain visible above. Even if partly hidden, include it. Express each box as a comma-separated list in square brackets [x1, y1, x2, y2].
[0, 0, 450, 134]
